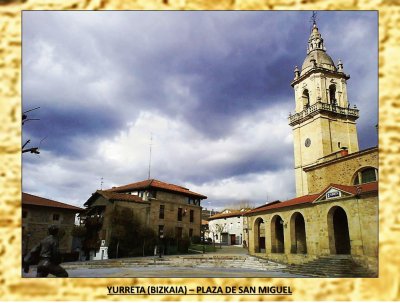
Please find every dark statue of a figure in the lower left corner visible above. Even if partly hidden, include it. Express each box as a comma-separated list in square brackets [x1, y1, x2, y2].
[23, 225, 68, 278]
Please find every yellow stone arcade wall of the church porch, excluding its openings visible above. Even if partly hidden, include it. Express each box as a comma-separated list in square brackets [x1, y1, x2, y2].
[249, 195, 378, 272]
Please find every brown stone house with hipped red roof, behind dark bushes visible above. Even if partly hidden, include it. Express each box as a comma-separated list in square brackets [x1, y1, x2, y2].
[84, 179, 207, 259]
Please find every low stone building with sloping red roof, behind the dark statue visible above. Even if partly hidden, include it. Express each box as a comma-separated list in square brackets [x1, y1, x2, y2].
[22, 193, 84, 254]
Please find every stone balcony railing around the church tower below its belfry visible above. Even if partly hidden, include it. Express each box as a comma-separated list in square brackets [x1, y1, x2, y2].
[289, 102, 359, 126]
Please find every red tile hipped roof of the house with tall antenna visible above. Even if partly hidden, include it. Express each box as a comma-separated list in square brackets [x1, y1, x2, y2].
[107, 179, 207, 199]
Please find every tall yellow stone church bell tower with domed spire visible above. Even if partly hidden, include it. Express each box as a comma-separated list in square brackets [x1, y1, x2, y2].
[289, 21, 359, 196]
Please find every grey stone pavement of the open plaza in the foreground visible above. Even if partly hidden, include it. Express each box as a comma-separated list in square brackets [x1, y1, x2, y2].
[22, 246, 304, 278]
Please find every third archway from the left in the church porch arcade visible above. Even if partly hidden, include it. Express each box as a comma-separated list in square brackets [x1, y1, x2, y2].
[290, 212, 307, 254]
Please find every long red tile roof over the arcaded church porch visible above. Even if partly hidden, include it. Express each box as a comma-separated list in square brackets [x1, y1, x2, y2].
[246, 182, 378, 215]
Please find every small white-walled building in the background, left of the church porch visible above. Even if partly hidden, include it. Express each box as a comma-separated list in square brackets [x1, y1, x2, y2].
[208, 209, 247, 245]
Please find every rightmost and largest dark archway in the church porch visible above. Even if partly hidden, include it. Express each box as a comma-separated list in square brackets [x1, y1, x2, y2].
[328, 206, 351, 255]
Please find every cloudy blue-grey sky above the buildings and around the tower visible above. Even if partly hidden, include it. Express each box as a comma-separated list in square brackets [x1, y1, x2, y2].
[22, 11, 378, 209]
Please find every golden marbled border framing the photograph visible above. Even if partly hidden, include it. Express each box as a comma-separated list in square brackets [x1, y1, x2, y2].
[0, 0, 400, 301]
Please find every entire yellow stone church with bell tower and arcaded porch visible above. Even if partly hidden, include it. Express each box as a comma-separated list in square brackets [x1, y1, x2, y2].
[246, 23, 378, 273]
